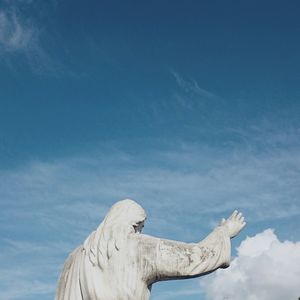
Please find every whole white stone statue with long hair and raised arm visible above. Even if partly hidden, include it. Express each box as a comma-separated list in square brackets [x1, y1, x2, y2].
[55, 199, 246, 300]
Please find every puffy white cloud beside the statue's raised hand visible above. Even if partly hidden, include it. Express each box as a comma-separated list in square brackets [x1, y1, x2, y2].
[201, 229, 300, 300]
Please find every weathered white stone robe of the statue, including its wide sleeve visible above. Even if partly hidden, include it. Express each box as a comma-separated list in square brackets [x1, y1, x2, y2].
[55, 226, 231, 300]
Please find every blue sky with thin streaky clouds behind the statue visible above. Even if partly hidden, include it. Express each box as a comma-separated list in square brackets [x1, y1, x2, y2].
[0, 0, 300, 300]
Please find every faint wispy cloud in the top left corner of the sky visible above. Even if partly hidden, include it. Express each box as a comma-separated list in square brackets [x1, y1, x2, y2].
[0, 0, 60, 75]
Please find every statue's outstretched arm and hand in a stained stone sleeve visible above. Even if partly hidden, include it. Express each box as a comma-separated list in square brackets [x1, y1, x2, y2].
[151, 211, 245, 281]
